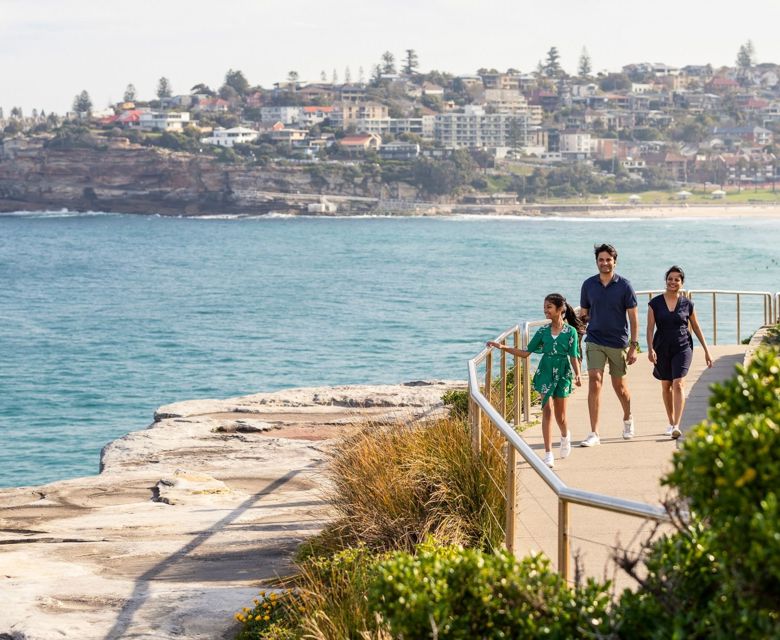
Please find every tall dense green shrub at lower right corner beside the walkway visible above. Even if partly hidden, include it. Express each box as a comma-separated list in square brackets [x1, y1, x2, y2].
[615, 348, 780, 638]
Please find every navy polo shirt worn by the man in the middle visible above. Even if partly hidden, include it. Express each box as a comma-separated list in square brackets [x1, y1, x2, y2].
[580, 274, 637, 349]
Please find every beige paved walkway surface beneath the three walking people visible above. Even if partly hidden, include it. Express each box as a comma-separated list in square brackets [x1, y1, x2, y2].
[518, 345, 746, 588]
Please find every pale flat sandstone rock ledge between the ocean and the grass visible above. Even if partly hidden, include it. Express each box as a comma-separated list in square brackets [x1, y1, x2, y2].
[0, 381, 463, 640]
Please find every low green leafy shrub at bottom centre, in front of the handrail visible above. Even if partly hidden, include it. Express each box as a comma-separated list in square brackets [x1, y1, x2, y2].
[368, 541, 609, 640]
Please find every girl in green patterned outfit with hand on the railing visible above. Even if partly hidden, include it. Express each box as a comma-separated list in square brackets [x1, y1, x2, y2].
[487, 293, 585, 469]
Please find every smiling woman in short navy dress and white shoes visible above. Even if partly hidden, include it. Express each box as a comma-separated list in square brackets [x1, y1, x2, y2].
[647, 265, 712, 439]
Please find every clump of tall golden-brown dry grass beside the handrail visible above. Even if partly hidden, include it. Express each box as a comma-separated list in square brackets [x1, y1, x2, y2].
[309, 418, 506, 553]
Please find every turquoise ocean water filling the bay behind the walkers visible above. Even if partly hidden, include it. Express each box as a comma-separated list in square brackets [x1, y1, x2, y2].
[0, 213, 780, 486]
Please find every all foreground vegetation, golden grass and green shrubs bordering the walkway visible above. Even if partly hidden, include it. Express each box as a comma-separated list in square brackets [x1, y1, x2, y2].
[236, 336, 780, 640]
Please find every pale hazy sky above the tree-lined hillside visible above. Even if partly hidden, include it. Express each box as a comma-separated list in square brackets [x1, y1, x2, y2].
[0, 0, 780, 115]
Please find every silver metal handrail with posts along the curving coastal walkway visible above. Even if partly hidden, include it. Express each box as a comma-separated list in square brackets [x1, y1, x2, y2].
[468, 289, 780, 580]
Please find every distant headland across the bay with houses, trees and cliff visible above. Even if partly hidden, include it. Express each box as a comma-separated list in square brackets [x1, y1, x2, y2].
[0, 54, 780, 214]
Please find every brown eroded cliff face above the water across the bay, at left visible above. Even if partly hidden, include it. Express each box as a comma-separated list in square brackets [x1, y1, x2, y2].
[0, 139, 417, 216]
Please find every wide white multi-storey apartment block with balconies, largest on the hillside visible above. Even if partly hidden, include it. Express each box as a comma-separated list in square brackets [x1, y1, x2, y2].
[433, 105, 528, 149]
